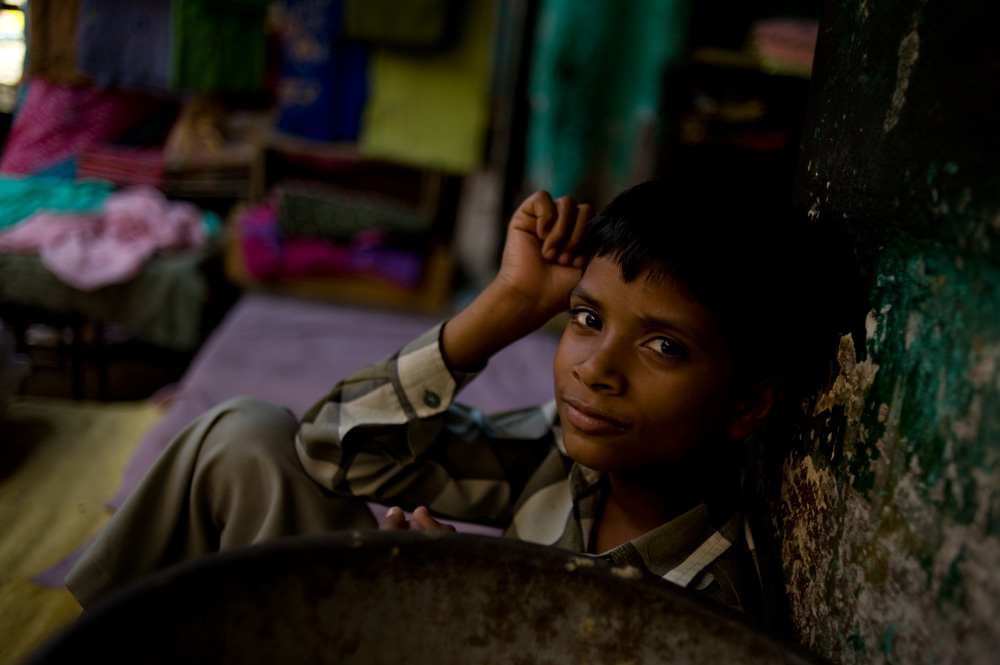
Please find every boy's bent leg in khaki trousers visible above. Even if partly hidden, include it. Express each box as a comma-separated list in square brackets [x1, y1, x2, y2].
[66, 397, 377, 606]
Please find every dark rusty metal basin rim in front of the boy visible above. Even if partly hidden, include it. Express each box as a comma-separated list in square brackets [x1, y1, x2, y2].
[28, 531, 819, 665]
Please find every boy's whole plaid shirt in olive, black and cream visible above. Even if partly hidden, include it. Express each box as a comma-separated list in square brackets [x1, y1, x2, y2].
[296, 326, 763, 616]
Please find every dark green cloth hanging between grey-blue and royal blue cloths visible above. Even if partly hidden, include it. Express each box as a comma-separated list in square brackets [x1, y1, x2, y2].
[172, 0, 267, 92]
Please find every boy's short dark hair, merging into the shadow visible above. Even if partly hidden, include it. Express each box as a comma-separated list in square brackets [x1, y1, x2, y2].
[582, 175, 836, 394]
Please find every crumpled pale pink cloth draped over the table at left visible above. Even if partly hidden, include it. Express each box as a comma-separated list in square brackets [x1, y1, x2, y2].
[0, 187, 205, 291]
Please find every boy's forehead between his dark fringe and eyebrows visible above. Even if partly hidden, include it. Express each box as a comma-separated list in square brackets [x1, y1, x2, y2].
[573, 257, 728, 355]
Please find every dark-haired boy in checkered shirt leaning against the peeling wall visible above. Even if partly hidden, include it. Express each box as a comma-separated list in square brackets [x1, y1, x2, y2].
[67, 176, 792, 614]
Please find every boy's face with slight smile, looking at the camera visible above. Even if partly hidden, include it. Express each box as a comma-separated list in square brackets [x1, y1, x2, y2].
[555, 252, 737, 474]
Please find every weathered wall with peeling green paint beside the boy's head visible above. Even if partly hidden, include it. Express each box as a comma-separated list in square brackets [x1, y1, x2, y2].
[766, 0, 1000, 663]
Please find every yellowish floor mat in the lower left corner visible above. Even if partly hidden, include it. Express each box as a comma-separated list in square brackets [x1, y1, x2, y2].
[0, 397, 160, 665]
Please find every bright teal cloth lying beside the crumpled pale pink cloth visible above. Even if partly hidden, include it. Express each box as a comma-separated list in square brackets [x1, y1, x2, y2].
[0, 177, 114, 229]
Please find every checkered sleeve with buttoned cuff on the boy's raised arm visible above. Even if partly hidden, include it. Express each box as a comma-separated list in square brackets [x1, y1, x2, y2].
[296, 326, 552, 521]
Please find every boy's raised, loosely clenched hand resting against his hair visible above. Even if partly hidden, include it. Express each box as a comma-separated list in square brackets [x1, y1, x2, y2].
[497, 191, 594, 325]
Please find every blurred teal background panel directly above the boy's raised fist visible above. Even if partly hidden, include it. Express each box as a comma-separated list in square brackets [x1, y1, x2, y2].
[526, 0, 690, 202]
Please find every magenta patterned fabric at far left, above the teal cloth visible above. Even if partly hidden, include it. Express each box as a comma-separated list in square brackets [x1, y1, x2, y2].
[0, 78, 162, 175]
